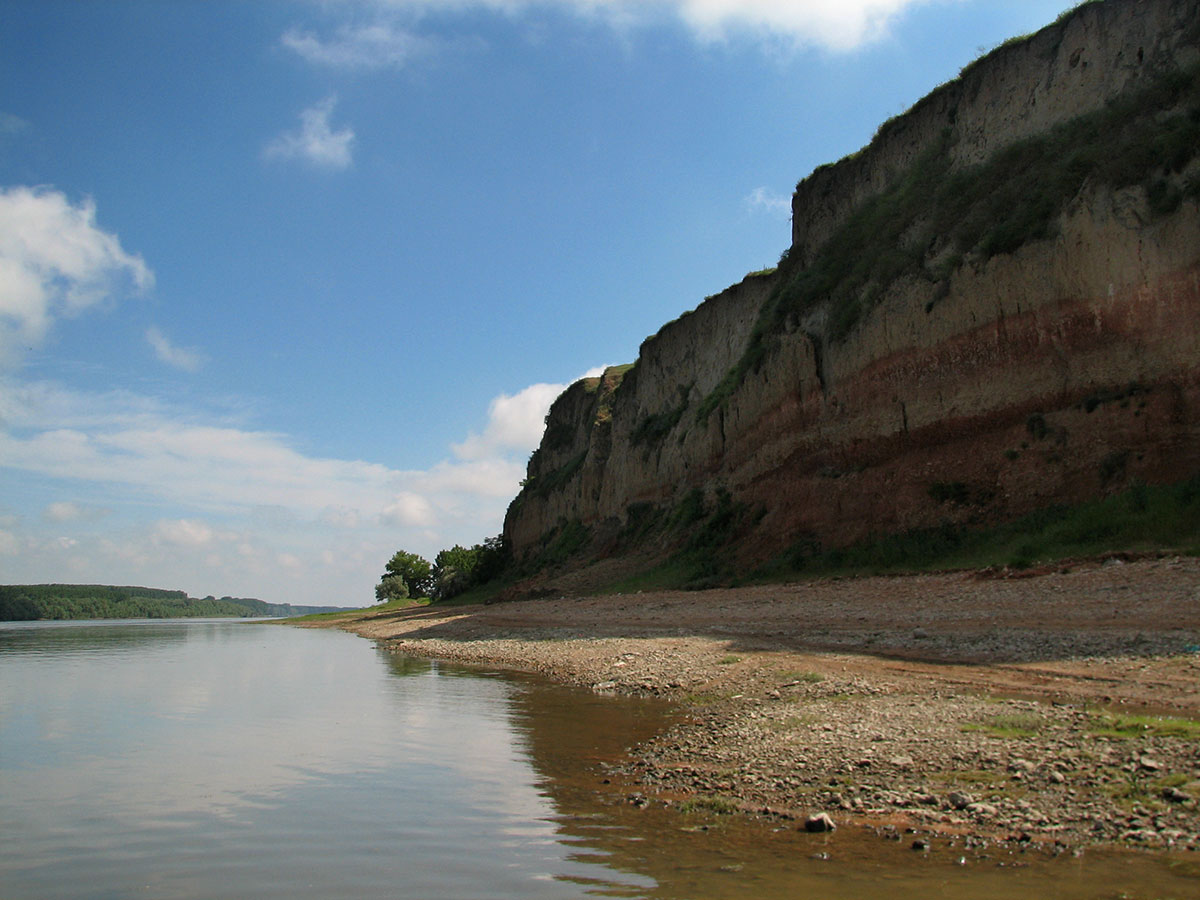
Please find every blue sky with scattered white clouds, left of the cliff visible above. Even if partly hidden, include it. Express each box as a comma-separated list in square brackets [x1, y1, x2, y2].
[0, 0, 1074, 606]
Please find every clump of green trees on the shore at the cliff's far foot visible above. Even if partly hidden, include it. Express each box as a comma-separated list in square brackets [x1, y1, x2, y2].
[376, 535, 511, 602]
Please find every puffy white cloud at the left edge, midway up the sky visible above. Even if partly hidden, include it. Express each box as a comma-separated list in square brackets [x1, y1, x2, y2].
[0, 187, 154, 366]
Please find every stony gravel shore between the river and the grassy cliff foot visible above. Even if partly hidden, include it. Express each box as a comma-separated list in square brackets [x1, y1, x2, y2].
[316, 558, 1200, 851]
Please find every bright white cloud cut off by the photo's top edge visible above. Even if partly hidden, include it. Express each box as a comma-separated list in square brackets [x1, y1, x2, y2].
[364, 0, 937, 50]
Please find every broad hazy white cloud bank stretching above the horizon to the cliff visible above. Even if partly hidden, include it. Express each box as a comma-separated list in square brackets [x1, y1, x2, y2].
[0, 370, 600, 605]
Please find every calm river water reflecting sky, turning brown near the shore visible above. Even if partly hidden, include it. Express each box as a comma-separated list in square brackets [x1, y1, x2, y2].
[0, 620, 1200, 900]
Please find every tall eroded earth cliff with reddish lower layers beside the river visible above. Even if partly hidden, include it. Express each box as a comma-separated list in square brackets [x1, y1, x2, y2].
[505, 0, 1200, 585]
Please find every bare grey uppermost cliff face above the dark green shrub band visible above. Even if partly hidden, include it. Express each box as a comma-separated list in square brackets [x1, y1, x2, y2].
[792, 0, 1200, 267]
